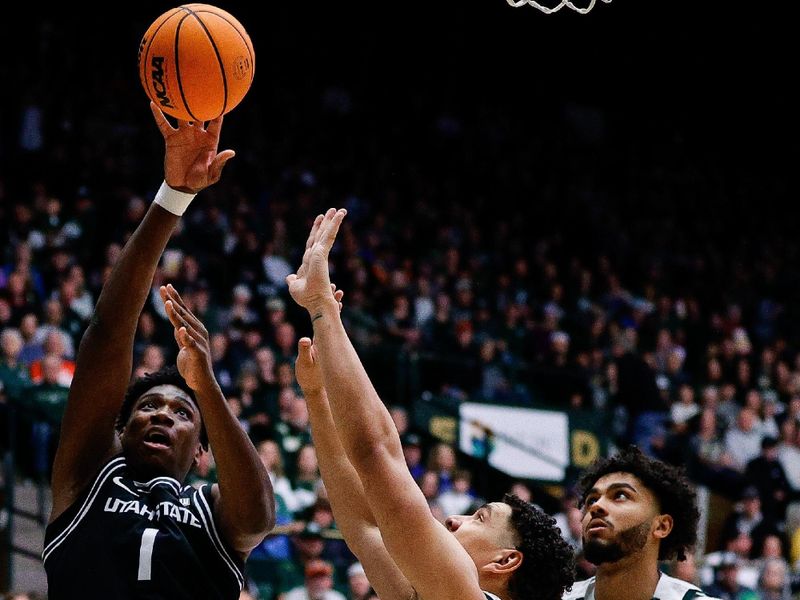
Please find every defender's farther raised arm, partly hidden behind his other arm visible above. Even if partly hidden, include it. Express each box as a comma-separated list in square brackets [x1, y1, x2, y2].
[295, 330, 414, 600]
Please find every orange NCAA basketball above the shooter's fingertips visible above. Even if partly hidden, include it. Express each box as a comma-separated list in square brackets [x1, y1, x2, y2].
[138, 4, 255, 121]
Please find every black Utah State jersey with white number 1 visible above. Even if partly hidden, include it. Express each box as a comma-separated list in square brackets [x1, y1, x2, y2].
[42, 456, 244, 600]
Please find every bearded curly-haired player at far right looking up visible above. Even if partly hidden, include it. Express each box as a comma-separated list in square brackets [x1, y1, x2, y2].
[564, 446, 720, 600]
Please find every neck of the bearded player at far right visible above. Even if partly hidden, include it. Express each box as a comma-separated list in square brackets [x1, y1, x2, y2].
[594, 553, 661, 600]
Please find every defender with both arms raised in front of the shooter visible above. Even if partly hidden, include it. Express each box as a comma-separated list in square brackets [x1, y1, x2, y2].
[287, 209, 574, 600]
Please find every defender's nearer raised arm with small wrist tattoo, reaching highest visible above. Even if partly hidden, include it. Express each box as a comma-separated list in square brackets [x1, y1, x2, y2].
[287, 209, 485, 600]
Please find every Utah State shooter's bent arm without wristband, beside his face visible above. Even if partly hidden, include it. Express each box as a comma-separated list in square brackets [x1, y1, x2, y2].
[160, 285, 275, 558]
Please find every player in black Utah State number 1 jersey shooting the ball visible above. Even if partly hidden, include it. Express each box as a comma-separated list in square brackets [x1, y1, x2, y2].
[43, 103, 274, 600]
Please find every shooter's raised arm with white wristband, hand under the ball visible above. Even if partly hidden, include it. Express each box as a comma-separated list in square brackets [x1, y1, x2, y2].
[50, 102, 234, 520]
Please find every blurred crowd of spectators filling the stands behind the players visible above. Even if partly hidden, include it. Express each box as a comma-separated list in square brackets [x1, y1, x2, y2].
[0, 5, 800, 600]
